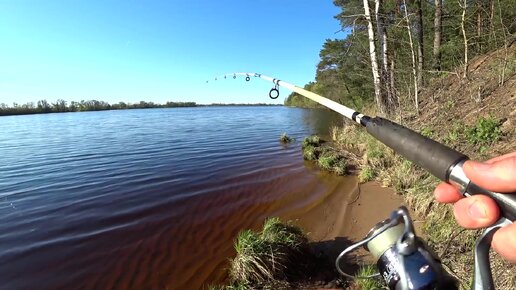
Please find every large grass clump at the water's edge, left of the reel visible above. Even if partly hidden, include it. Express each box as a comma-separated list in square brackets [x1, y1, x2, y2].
[226, 218, 310, 289]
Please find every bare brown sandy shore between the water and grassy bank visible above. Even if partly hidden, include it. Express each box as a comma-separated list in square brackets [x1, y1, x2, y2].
[210, 169, 404, 289]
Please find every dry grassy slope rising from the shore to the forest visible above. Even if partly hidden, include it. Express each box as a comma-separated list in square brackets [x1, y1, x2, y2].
[333, 43, 516, 289]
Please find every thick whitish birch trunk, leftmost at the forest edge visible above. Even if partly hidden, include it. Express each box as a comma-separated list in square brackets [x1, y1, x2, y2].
[363, 0, 386, 115]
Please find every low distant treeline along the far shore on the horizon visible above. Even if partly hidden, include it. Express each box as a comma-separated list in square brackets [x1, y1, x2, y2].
[0, 99, 282, 116]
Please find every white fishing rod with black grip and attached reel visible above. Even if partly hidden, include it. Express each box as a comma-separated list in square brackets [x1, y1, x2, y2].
[215, 72, 516, 290]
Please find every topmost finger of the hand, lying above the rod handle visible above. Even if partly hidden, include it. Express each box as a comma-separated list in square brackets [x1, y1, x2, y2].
[464, 156, 516, 192]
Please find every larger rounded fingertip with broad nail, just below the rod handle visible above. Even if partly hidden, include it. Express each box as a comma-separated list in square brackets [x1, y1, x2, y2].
[453, 195, 500, 229]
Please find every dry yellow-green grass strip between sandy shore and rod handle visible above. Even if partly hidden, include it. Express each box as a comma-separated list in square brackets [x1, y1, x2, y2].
[332, 121, 476, 289]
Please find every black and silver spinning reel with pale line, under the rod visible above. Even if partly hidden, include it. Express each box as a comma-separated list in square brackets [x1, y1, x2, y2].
[335, 207, 507, 290]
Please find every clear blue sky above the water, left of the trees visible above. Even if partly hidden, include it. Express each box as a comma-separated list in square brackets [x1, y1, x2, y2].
[0, 0, 344, 104]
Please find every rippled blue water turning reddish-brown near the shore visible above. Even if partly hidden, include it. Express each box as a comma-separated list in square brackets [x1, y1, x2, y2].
[0, 107, 348, 289]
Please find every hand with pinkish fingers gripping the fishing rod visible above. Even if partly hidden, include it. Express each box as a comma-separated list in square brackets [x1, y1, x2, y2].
[434, 152, 516, 263]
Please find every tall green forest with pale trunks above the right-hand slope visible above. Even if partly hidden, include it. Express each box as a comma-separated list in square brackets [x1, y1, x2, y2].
[285, 0, 516, 117]
